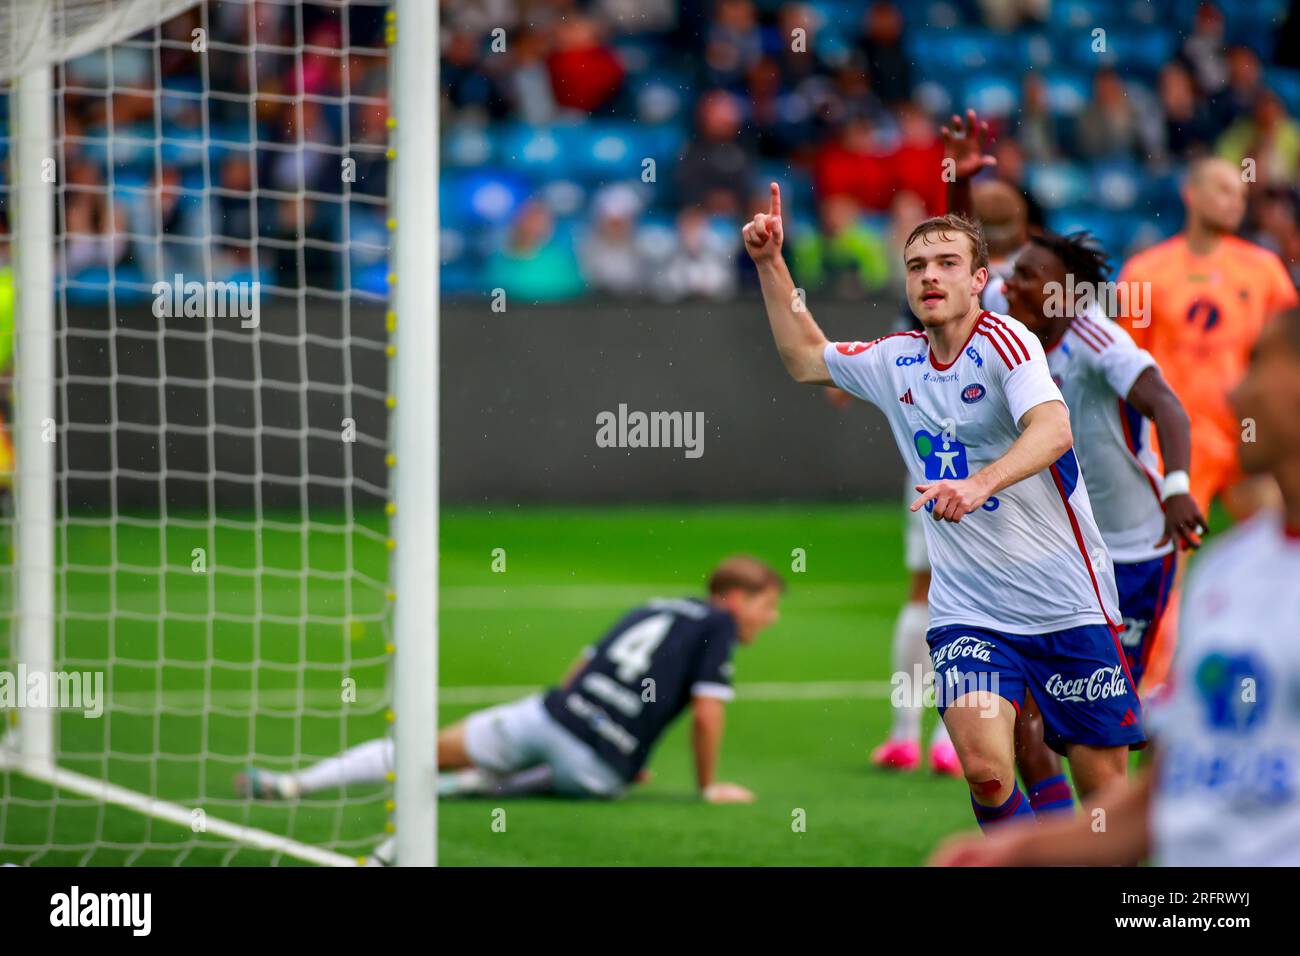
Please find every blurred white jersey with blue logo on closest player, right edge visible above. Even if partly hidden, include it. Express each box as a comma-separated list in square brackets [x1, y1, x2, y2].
[1152, 514, 1300, 866]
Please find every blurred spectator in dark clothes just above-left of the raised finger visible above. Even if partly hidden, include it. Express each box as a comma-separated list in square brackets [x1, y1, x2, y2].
[677, 90, 754, 215]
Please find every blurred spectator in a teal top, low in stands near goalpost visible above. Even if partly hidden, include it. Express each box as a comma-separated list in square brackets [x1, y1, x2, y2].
[484, 199, 584, 307]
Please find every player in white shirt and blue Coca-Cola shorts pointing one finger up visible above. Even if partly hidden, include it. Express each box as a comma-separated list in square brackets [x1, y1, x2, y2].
[744, 183, 1145, 825]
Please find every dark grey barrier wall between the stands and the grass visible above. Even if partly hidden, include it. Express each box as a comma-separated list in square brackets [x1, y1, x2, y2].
[60, 294, 902, 509]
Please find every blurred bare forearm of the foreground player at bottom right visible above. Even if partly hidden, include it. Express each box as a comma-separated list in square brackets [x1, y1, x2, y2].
[931, 771, 1153, 866]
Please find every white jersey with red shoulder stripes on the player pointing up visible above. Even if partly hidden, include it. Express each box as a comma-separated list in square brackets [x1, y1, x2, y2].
[826, 312, 1121, 635]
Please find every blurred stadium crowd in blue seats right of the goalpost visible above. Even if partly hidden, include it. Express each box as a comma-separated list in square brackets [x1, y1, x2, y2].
[442, 0, 1300, 302]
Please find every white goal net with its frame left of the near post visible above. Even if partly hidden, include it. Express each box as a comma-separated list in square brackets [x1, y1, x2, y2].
[0, 0, 436, 865]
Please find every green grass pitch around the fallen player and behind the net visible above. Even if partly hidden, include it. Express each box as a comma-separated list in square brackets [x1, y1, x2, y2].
[0, 502, 1003, 865]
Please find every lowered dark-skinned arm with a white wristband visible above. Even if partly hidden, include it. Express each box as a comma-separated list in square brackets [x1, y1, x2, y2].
[1127, 365, 1205, 549]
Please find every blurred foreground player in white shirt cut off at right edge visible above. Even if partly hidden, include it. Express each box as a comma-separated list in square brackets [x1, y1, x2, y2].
[933, 310, 1300, 866]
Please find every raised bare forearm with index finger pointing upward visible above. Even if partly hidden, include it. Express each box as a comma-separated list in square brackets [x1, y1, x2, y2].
[741, 182, 833, 385]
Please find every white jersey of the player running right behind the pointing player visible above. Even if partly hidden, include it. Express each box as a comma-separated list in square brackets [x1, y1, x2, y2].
[1048, 315, 1174, 564]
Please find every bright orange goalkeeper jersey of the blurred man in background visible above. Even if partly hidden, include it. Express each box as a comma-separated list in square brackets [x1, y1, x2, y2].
[1119, 235, 1296, 436]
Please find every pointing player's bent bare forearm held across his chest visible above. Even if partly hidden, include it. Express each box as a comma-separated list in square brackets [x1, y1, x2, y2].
[911, 401, 1074, 522]
